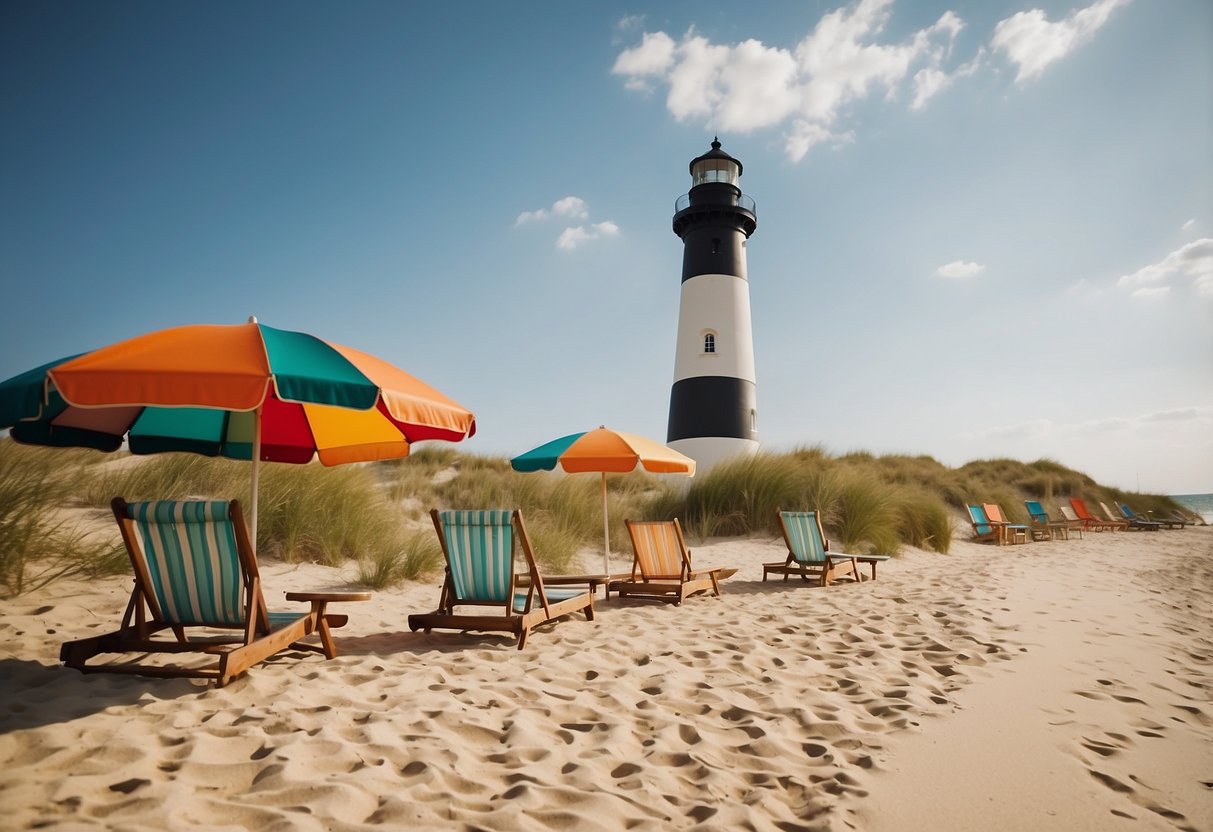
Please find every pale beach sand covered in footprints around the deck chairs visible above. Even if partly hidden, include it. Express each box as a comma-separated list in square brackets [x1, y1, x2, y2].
[0, 528, 1213, 832]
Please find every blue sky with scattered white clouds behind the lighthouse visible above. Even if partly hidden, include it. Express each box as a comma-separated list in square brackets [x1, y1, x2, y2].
[0, 0, 1213, 494]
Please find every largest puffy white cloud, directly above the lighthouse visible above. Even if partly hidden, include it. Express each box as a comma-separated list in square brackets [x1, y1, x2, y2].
[611, 0, 972, 161]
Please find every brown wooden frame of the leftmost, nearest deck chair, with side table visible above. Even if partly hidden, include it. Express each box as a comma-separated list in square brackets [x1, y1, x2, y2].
[59, 497, 359, 686]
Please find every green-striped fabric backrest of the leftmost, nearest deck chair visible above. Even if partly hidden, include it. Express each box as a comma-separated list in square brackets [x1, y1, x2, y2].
[121, 500, 247, 626]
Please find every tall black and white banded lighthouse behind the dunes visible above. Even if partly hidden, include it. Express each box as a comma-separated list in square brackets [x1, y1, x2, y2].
[666, 138, 758, 472]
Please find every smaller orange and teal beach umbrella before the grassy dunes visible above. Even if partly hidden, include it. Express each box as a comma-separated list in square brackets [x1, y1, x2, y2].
[509, 427, 695, 575]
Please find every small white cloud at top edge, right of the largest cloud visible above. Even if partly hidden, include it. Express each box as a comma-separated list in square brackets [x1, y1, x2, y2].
[990, 0, 1129, 84]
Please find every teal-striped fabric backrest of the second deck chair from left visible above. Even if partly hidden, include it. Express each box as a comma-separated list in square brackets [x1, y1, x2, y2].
[432, 508, 514, 603]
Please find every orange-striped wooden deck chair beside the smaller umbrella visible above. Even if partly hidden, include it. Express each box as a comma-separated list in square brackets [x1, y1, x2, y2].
[607, 519, 724, 605]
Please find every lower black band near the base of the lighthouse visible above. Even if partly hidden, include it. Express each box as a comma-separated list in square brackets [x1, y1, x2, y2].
[666, 376, 758, 441]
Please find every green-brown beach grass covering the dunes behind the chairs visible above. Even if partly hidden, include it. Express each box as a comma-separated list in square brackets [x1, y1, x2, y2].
[0, 439, 1180, 593]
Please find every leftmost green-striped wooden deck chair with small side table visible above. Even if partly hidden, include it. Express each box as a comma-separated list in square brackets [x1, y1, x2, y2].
[59, 497, 370, 686]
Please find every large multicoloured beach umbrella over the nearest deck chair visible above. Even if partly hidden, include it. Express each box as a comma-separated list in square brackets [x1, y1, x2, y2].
[0, 318, 475, 540]
